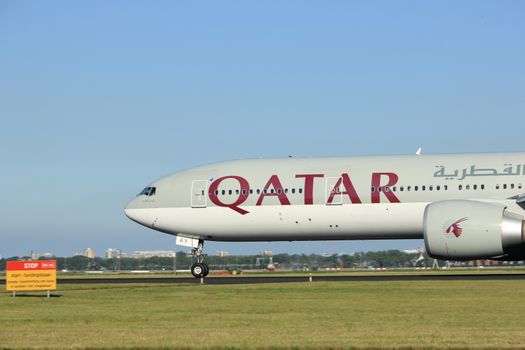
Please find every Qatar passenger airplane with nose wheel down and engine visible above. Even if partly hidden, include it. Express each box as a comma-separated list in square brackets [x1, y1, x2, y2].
[125, 151, 525, 278]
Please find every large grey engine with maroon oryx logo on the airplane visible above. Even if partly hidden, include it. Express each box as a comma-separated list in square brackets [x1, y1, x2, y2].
[423, 200, 525, 260]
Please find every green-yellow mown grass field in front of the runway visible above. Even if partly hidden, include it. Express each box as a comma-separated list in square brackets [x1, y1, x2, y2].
[0, 281, 525, 349]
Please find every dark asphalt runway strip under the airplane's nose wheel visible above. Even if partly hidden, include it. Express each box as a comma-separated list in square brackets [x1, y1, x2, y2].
[6, 273, 525, 285]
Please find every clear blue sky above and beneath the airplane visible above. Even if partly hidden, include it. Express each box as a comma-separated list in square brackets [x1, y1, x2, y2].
[0, 0, 525, 256]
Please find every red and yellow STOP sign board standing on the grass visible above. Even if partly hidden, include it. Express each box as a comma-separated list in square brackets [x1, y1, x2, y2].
[6, 260, 57, 298]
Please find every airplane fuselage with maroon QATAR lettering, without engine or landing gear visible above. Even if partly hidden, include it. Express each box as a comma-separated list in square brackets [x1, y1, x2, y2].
[126, 153, 525, 241]
